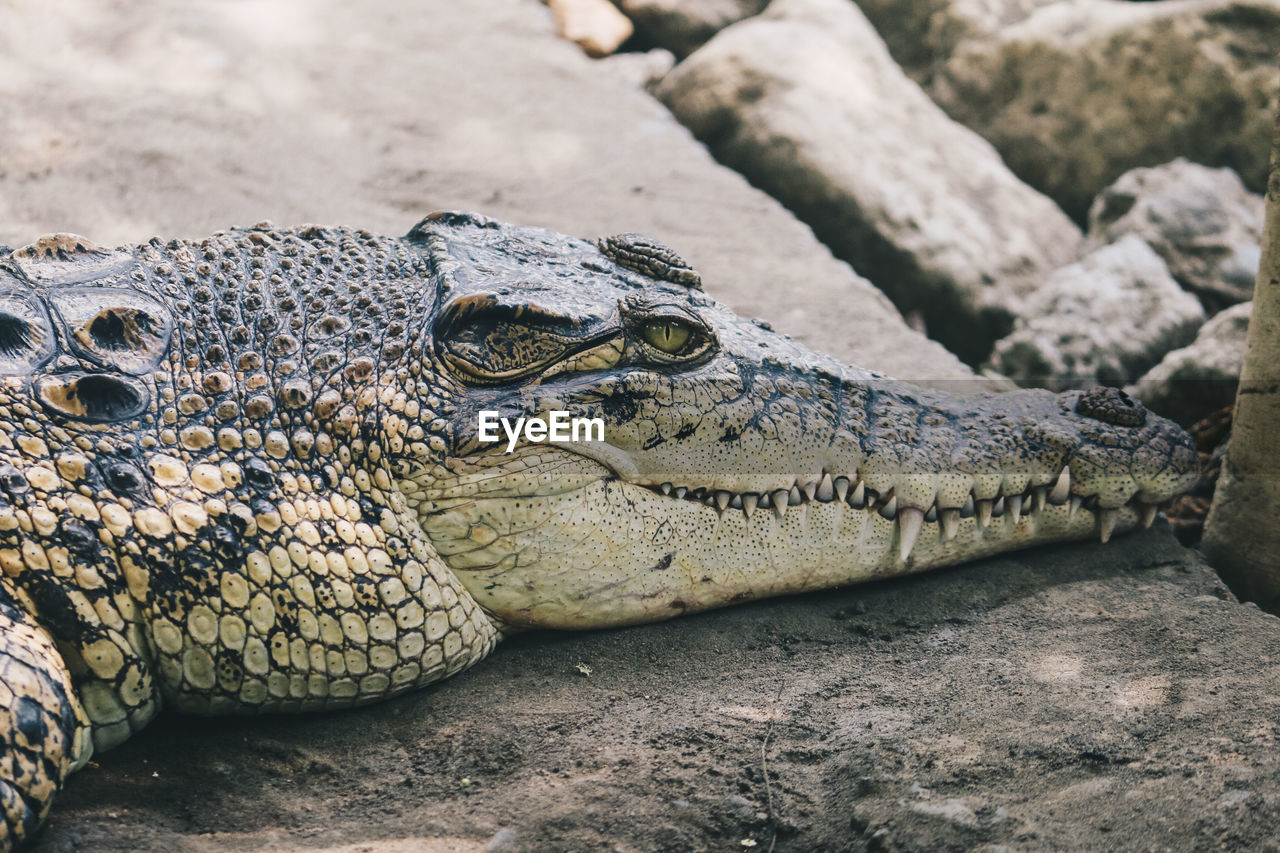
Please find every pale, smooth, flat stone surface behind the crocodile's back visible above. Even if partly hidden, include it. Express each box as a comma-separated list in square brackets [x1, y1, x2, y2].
[0, 0, 973, 382]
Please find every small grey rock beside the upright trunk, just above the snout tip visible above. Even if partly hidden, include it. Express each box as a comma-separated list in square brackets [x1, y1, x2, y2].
[1129, 302, 1253, 424]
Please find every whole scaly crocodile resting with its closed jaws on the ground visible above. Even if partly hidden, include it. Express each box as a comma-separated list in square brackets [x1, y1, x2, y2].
[0, 213, 1197, 849]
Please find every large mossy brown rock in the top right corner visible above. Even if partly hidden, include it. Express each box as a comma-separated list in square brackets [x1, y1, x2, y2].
[929, 0, 1280, 220]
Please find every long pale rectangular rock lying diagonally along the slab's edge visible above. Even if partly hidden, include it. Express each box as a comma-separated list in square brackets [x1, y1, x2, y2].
[657, 0, 1080, 364]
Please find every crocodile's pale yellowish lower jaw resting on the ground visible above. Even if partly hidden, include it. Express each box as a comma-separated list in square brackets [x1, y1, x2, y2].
[408, 450, 1152, 628]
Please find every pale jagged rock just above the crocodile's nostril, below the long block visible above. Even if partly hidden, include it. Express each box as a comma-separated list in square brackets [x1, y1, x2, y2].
[992, 234, 1204, 388]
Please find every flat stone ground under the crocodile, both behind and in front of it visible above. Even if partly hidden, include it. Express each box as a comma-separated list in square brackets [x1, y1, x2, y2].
[0, 0, 1280, 853]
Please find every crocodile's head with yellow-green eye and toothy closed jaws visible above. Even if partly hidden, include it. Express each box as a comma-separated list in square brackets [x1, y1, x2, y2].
[399, 214, 1196, 628]
